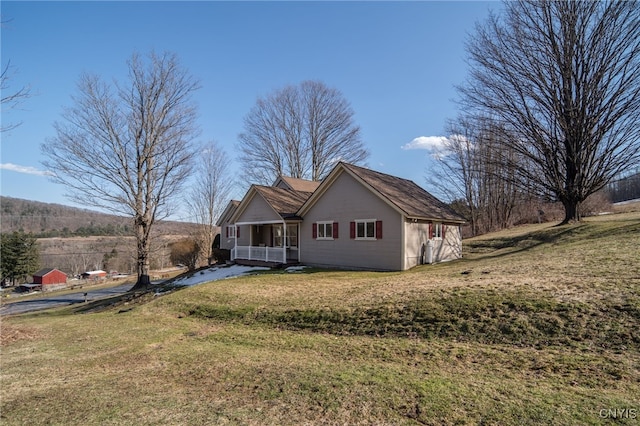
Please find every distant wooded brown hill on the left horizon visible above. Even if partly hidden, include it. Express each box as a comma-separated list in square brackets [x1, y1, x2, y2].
[0, 196, 193, 238]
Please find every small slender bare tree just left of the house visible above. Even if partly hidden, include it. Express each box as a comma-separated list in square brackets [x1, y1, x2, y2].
[186, 142, 233, 263]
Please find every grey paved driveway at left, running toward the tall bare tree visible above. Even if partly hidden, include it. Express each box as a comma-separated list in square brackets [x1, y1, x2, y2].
[0, 283, 133, 315]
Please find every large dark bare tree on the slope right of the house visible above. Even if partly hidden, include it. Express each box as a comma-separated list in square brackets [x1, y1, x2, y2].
[460, 0, 640, 223]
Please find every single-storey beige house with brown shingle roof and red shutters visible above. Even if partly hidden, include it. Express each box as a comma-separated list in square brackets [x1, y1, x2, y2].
[219, 162, 464, 271]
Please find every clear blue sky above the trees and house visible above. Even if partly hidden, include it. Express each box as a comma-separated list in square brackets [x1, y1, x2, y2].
[0, 1, 500, 218]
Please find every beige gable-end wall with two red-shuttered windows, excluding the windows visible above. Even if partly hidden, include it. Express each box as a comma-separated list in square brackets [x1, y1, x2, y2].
[300, 173, 404, 270]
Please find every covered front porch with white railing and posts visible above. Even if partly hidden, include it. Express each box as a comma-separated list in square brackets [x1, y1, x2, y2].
[231, 220, 300, 264]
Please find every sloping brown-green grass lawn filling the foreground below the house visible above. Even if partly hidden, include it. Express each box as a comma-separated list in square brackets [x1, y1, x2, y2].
[0, 213, 640, 425]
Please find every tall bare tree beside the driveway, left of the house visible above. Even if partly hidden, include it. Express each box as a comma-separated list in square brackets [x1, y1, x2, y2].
[42, 53, 199, 290]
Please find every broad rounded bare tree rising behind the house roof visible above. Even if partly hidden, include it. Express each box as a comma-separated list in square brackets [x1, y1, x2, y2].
[239, 81, 369, 185]
